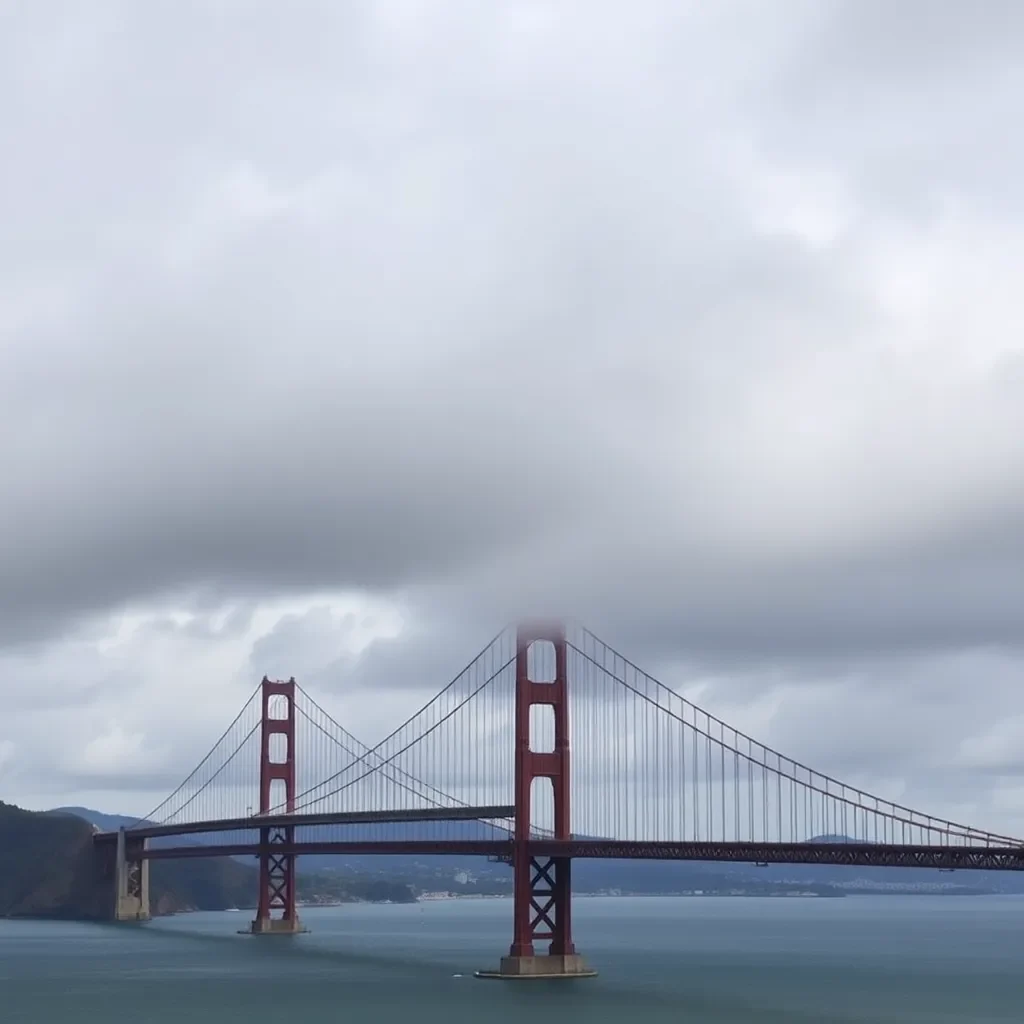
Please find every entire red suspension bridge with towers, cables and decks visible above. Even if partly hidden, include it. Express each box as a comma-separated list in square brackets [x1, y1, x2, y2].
[95, 626, 1024, 978]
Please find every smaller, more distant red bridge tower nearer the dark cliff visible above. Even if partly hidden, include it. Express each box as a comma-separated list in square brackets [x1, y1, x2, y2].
[252, 676, 305, 935]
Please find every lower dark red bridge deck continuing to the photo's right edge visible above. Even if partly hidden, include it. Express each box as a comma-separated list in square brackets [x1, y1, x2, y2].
[132, 835, 1024, 871]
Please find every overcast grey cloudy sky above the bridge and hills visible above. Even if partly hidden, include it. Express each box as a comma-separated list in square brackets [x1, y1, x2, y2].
[0, 0, 1024, 835]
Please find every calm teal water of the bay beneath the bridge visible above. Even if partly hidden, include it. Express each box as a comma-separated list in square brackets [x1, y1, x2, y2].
[0, 896, 1024, 1024]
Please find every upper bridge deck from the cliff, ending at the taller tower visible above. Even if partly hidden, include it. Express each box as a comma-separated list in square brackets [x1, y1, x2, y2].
[93, 805, 515, 843]
